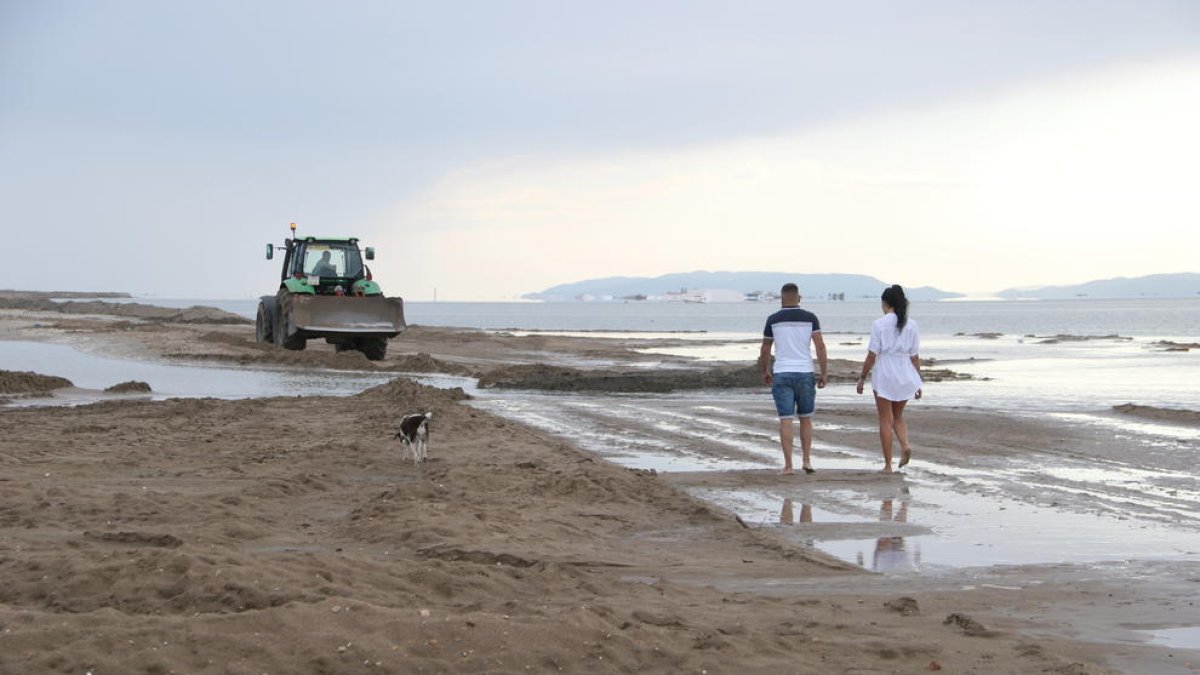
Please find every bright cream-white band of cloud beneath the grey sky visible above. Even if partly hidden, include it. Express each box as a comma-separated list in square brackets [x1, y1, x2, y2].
[379, 58, 1200, 299]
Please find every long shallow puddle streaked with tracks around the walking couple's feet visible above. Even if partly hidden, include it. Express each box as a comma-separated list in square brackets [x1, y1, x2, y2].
[475, 392, 1200, 575]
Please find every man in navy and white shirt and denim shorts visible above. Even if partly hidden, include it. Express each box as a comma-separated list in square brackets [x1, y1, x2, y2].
[758, 283, 829, 474]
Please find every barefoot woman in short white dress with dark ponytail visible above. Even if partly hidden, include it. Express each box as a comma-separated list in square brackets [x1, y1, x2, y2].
[858, 286, 922, 473]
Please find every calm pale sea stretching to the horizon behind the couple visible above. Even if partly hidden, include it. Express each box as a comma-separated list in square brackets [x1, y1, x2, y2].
[32, 298, 1200, 413]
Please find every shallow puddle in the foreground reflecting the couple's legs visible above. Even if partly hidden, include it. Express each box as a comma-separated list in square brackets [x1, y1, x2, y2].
[689, 478, 1200, 574]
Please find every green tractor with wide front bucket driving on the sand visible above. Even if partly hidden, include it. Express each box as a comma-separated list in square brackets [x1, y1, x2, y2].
[254, 222, 406, 360]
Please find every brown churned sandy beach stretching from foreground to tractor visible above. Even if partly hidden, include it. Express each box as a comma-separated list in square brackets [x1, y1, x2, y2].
[0, 304, 1200, 675]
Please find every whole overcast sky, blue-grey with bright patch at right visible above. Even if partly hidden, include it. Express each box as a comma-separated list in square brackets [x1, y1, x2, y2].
[0, 0, 1200, 300]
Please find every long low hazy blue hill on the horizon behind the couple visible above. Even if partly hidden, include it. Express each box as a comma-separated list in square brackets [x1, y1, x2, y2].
[524, 271, 961, 301]
